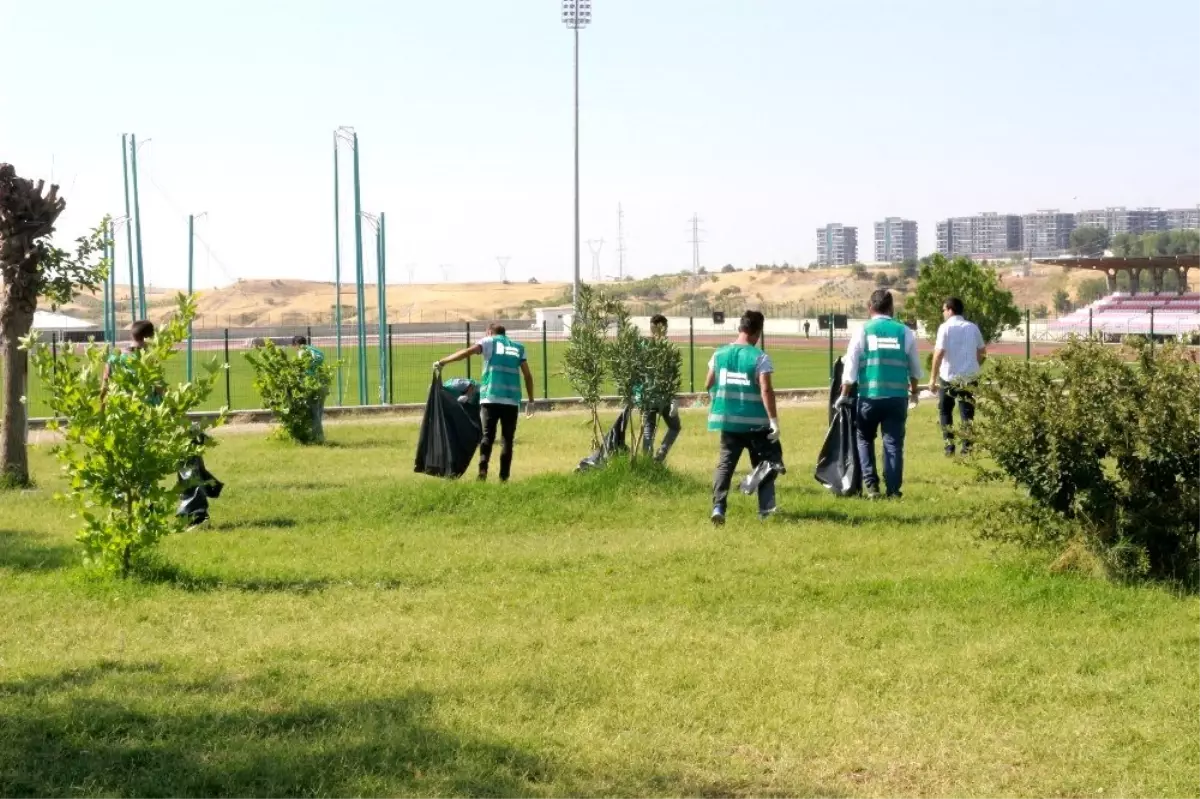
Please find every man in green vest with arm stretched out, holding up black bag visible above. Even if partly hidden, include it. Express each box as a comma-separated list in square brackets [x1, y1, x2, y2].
[433, 322, 533, 482]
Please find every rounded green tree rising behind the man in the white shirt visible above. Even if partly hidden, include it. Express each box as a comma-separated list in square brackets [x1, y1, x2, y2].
[905, 254, 1021, 341]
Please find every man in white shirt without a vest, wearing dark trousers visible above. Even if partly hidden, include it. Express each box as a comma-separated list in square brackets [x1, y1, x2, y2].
[929, 296, 988, 457]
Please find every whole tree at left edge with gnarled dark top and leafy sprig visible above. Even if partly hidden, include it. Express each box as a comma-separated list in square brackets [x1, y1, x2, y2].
[0, 163, 108, 487]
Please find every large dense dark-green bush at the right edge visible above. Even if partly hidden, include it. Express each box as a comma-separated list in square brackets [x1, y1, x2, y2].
[973, 340, 1200, 583]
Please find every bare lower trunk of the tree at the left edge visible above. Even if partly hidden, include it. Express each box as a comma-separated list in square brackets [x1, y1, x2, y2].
[0, 287, 34, 488]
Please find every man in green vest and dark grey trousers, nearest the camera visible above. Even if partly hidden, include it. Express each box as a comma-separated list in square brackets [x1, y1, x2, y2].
[704, 311, 782, 527]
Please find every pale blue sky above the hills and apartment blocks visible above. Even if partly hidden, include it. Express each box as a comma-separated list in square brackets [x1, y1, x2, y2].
[0, 0, 1200, 288]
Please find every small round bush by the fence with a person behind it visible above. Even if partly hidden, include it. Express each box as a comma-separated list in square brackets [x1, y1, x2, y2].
[246, 340, 334, 444]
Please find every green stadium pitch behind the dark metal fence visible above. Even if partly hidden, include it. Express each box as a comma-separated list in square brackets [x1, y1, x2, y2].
[14, 342, 845, 417]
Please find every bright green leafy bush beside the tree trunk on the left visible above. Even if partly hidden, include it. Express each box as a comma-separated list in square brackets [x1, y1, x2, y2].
[24, 295, 224, 576]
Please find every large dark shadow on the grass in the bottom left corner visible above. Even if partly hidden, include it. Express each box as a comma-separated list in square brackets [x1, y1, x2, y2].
[0, 666, 554, 798]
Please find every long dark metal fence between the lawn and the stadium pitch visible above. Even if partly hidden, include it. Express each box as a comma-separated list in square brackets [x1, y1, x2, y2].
[29, 311, 1195, 417]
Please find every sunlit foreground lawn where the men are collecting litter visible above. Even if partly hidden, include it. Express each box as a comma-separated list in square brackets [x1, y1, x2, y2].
[0, 407, 1200, 797]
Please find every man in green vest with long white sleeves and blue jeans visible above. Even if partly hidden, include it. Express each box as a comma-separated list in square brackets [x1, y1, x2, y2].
[838, 289, 923, 499]
